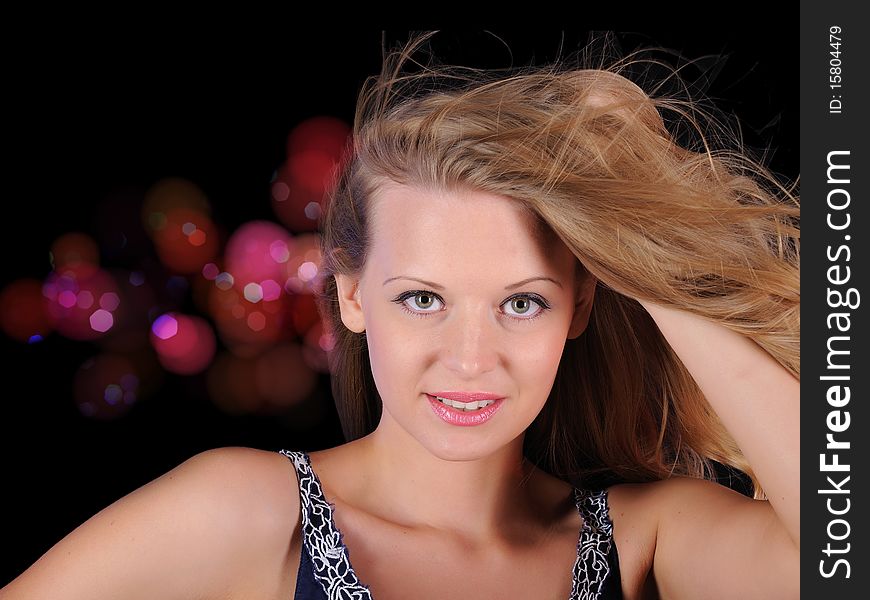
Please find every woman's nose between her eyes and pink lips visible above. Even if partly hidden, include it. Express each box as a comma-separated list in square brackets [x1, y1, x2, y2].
[441, 305, 501, 380]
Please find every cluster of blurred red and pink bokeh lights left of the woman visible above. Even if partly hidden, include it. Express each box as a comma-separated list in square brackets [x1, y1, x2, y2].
[0, 116, 350, 425]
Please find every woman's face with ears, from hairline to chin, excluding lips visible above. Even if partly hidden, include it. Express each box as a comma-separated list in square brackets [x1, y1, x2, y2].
[336, 184, 595, 460]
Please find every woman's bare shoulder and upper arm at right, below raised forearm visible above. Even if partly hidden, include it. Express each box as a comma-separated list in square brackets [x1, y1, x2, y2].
[609, 476, 799, 598]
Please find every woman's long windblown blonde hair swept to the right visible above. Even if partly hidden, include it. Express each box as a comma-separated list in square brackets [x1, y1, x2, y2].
[318, 32, 800, 498]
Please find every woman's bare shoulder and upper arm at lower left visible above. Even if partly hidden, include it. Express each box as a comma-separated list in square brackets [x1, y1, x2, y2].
[0, 447, 299, 600]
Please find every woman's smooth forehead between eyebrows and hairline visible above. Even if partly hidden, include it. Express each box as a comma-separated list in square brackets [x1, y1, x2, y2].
[369, 182, 573, 271]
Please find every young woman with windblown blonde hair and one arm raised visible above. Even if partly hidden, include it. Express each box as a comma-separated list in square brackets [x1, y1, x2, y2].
[0, 34, 800, 600]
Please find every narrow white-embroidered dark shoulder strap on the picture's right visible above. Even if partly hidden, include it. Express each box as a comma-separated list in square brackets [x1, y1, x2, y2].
[570, 488, 618, 600]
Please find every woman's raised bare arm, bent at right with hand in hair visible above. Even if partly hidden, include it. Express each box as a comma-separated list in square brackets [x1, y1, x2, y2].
[641, 301, 800, 597]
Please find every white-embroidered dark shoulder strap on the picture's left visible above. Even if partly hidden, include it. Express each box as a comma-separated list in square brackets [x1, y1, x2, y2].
[280, 450, 371, 600]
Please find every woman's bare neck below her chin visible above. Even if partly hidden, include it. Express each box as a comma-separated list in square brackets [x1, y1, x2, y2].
[358, 412, 534, 540]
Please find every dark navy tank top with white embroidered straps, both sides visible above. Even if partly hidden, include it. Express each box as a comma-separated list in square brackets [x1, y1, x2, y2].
[280, 450, 622, 600]
